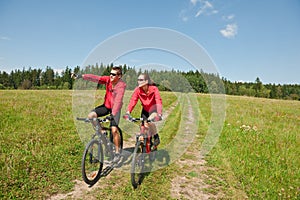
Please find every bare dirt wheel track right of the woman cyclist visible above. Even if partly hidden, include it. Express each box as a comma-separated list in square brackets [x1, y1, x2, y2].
[171, 95, 224, 199]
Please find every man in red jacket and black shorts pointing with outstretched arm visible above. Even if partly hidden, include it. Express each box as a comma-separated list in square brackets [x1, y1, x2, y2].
[71, 67, 126, 163]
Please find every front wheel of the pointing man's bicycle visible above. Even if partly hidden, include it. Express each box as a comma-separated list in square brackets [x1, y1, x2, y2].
[81, 139, 103, 185]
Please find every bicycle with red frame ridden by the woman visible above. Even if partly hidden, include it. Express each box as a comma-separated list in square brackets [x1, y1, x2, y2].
[124, 117, 162, 189]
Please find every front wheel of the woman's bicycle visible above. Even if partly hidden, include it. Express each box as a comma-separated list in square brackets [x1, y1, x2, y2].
[130, 141, 145, 188]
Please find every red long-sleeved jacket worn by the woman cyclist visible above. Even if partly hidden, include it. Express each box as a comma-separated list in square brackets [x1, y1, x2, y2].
[127, 85, 162, 115]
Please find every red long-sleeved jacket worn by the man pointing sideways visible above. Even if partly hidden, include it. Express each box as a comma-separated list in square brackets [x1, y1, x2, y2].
[83, 74, 126, 115]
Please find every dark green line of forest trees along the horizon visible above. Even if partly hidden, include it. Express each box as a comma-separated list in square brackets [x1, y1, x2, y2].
[0, 64, 300, 100]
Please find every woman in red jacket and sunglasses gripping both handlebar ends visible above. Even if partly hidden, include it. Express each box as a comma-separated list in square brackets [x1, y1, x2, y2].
[125, 74, 162, 150]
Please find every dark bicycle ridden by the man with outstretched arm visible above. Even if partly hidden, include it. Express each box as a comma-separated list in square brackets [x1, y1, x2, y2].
[76, 117, 123, 186]
